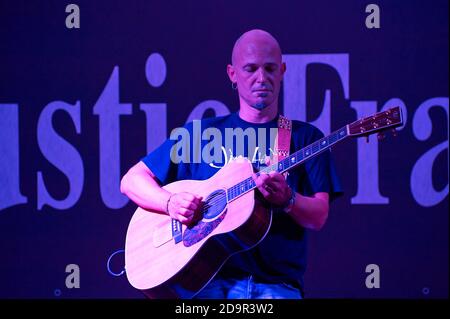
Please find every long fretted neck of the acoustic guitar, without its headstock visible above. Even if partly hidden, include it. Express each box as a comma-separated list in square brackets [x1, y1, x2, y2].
[227, 125, 348, 202]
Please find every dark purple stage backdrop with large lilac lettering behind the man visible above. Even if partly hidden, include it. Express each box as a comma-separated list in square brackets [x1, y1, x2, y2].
[0, 0, 449, 298]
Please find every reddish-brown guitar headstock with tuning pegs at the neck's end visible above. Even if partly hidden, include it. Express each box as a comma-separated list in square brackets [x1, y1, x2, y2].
[347, 106, 403, 137]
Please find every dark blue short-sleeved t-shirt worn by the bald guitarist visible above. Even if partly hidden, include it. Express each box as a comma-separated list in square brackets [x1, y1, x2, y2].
[142, 113, 342, 288]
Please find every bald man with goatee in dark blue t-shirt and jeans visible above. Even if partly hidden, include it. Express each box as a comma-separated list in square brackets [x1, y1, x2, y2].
[121, 30, 342, 299]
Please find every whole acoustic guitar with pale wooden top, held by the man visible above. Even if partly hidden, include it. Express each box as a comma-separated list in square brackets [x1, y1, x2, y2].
[125, 107, 403, 298]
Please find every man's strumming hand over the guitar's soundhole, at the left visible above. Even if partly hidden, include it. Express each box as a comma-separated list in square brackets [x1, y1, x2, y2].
[167, 192, 203, 225]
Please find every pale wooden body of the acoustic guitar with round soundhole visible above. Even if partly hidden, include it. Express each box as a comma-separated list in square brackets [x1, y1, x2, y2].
[125, 158, 272, 298]
